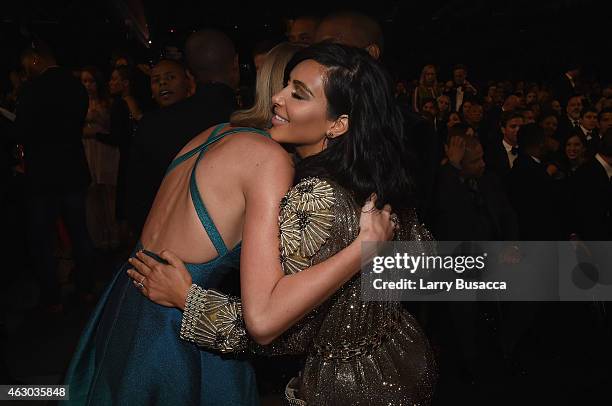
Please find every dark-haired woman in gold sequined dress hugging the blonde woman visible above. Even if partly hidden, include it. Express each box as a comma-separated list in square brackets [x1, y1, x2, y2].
[134, 44, 436, 405]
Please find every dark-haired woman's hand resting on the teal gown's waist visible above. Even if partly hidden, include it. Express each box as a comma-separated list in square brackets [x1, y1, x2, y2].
[127, 250, 192, 310]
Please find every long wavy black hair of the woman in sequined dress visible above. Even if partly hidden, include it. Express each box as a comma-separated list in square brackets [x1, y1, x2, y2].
[286, 43, 414, 210]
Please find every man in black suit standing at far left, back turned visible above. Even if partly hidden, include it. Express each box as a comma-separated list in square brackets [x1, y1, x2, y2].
[15, 43, 94, 312]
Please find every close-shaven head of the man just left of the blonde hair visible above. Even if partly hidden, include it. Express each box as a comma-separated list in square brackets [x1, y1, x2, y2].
[185, 30, 239, 88]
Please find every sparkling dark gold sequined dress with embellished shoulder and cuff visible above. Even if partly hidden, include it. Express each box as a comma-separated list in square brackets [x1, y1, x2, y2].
[183, 178, 437, 406]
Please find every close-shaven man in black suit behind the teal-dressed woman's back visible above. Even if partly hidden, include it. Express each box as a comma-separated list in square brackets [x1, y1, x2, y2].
[126, 30, 239, 235]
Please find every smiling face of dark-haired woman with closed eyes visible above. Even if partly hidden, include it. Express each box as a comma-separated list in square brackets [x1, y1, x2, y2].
[270, 60, 333, 158]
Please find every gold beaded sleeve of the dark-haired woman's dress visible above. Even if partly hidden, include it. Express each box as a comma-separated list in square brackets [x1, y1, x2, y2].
[180, 178, 335, 355]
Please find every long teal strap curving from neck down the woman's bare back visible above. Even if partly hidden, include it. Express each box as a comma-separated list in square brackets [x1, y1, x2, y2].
[189, 127, 270, 256]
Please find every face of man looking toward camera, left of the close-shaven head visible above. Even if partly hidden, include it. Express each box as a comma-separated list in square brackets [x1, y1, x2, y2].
[151, 61, 190, 107]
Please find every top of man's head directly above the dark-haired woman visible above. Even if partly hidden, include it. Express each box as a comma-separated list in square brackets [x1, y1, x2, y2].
[315, 11, 383, 59]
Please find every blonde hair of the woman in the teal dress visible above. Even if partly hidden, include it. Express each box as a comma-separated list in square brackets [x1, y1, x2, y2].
[230, 42, 304, 129]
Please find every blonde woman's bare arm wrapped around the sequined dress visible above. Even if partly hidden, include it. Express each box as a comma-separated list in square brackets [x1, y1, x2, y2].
[240, 161, 393, 344]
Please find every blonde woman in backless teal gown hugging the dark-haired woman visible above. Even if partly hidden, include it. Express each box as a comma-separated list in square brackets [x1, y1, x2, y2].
[65, 42, 393, 405]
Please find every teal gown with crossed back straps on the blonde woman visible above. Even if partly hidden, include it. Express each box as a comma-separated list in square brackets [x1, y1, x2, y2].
[65, 124, 269, 406]
